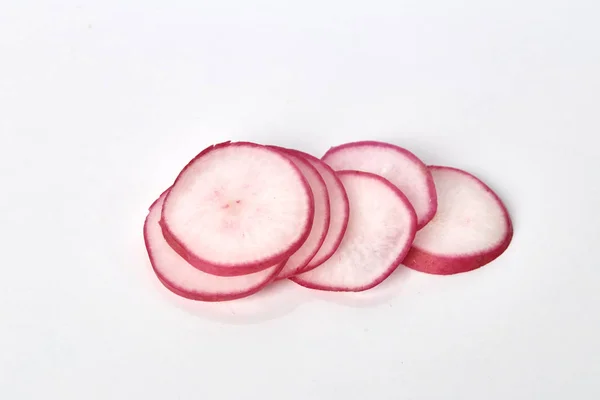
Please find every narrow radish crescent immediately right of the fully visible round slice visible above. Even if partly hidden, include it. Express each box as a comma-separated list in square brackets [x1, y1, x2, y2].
[269, 146, 329, 279]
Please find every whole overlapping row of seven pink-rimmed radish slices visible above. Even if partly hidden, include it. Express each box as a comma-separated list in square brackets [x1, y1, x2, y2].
[144, 142, 512, 301]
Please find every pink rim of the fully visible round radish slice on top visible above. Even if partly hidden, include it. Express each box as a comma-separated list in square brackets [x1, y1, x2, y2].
[160, 141, 315, 276]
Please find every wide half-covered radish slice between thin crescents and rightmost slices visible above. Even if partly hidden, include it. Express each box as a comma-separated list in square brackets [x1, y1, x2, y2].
[291, 171, 417, 292]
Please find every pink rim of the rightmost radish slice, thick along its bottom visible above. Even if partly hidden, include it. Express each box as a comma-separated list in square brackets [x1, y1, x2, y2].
[404, 165, 513, 275]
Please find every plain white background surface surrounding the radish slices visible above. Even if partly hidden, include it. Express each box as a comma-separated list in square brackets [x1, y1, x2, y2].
[0, 0, 600, 400]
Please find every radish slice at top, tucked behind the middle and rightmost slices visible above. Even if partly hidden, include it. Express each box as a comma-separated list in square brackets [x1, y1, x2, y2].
[322, 141, 437, 229]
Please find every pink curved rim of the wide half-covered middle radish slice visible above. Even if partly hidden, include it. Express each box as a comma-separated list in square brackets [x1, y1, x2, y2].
[290, 170, 417, 292]
